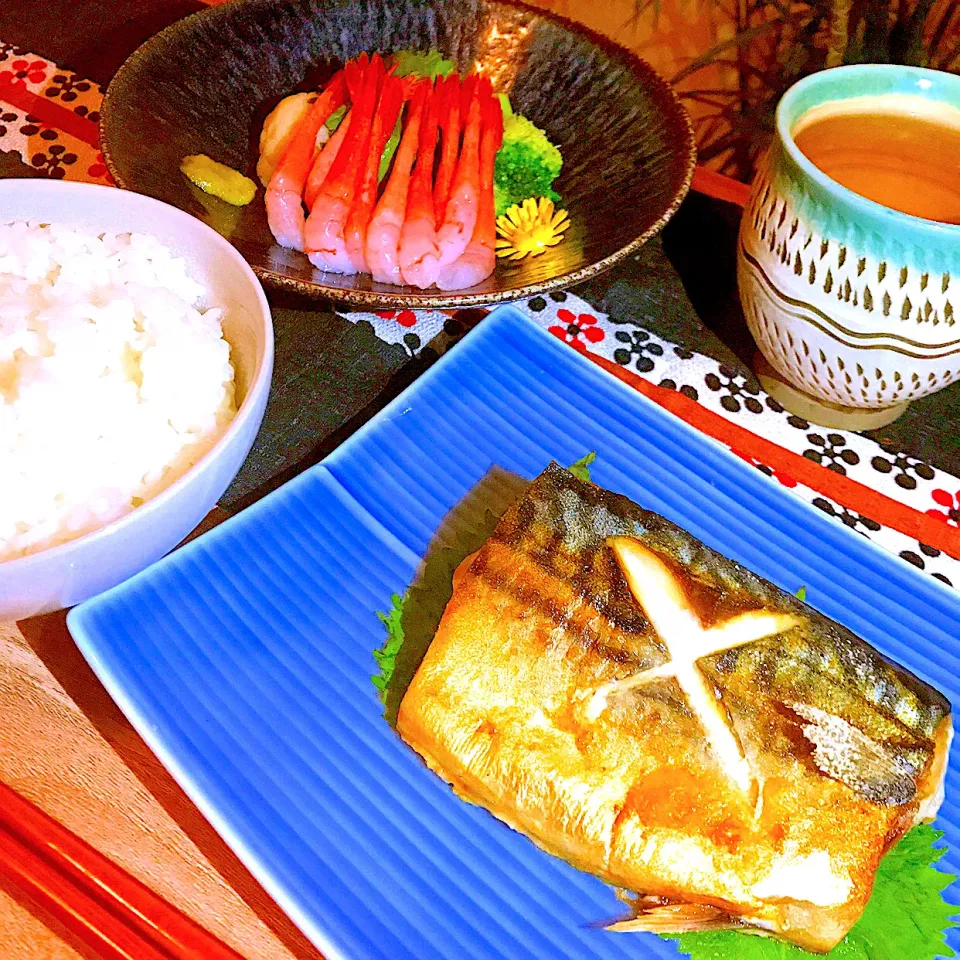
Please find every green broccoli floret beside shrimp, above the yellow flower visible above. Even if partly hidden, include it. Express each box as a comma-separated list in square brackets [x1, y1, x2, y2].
[493, 109, 563, 217]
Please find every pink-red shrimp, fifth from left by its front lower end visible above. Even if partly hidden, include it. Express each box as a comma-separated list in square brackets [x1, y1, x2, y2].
[400, 87, 440, 290]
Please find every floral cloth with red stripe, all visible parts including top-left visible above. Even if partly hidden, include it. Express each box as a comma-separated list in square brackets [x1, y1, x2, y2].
[0, 42, 960, 587]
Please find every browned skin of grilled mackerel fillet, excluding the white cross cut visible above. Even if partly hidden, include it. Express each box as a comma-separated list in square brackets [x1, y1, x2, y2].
[398, 464, 952, 951]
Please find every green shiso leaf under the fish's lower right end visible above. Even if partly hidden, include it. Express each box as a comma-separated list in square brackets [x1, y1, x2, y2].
[669, 823, 960, 960]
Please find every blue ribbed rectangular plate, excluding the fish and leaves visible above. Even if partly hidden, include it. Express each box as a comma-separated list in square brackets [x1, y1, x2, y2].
[69, 308, 960, 960]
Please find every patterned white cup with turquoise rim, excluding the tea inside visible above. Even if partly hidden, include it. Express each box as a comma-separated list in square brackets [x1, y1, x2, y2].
[737, 65, 960, 429]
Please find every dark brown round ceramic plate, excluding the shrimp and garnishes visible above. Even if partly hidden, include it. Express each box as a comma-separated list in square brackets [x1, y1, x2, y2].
[100, 0, 695, 307]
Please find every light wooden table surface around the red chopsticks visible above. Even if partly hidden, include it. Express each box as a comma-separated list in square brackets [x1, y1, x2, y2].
[0, 498, 321, 960]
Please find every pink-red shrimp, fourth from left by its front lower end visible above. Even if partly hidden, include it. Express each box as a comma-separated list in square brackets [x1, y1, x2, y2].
[364, 81, 430, 284]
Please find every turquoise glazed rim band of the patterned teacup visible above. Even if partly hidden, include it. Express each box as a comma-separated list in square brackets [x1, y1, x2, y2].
[773, 64, 960, 272]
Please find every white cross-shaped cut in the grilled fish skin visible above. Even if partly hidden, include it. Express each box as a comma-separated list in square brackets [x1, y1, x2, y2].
[586, 537, 797, 793]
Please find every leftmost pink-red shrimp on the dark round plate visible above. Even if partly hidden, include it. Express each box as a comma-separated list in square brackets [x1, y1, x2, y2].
[266, 71, 347, 250]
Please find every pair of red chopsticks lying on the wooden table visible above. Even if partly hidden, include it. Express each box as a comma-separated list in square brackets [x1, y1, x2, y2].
[0, 783, 251, 960]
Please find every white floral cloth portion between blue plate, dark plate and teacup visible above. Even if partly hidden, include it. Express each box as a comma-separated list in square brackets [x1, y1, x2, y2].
[332, 291, 960, 587]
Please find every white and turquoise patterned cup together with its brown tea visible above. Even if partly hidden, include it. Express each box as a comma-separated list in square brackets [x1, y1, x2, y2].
[737, 65, 960, 429]
